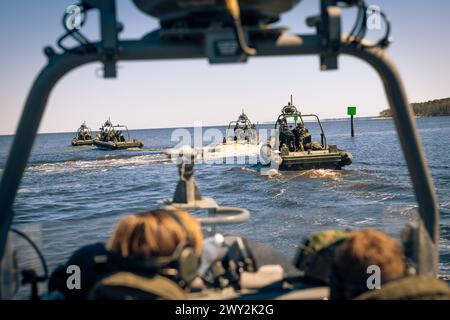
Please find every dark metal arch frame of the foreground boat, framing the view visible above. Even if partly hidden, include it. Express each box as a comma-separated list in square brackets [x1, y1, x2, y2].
[0, 0, 440, 274]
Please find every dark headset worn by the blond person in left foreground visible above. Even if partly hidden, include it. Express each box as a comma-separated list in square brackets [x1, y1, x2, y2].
[103, 209, 200, 287]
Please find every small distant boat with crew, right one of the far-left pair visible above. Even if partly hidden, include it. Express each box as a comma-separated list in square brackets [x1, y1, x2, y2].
[94, 119, 144, 150]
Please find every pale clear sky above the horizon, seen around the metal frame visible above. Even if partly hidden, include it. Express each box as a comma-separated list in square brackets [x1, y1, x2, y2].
[0, 0, 450, 134]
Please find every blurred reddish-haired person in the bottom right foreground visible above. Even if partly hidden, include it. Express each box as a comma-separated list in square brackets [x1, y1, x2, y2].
[330, 229, 450, 300]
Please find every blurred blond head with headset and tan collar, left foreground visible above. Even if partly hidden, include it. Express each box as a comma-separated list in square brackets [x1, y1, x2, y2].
[89, 210, 202, 300]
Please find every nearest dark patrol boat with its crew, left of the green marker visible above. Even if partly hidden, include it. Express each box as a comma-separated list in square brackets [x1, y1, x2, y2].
[268, 96, 352, 170]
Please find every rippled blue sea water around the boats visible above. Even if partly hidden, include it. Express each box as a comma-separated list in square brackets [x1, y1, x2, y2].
[0, 117, 450, 296]
